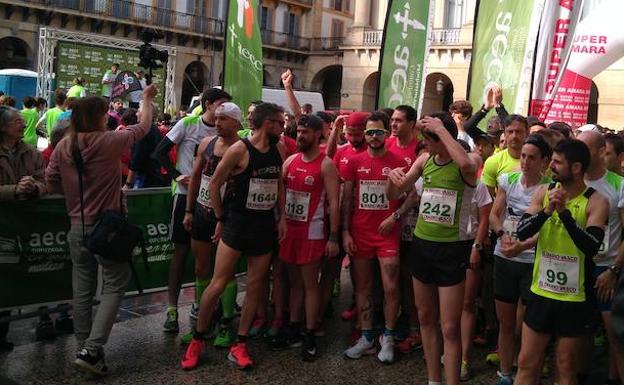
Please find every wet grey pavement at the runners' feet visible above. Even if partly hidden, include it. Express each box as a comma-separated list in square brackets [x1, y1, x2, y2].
[0, 268, 604, 385]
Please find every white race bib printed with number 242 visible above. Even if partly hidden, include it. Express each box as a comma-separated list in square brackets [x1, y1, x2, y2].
[419, 188, 457, 226]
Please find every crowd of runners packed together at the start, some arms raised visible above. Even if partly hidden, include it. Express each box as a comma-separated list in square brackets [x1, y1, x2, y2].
[0, 71, 624, 385]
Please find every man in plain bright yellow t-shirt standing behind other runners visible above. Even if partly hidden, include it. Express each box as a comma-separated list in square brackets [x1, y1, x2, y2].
[481, 114, 529, 196]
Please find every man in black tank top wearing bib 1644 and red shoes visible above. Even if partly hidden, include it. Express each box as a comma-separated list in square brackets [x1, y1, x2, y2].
[182, 103, 286, 369]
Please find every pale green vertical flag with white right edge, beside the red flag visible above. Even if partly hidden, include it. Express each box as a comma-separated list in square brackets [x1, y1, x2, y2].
[468, 0, 545, 118]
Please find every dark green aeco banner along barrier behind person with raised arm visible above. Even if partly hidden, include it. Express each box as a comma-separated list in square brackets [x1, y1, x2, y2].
[0, 188, 194, 308]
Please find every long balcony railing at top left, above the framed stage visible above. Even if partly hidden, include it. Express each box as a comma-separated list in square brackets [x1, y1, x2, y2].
[12, 0, 223, 36]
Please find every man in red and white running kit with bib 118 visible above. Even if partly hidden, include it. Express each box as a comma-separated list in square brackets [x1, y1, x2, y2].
[279, 115, 340, 361]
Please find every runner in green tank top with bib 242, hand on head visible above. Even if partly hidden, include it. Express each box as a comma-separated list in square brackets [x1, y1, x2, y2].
[387, 113, 480, 385]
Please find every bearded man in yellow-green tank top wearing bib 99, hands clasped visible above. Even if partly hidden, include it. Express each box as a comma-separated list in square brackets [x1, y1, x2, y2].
[514, 139, 609, 385]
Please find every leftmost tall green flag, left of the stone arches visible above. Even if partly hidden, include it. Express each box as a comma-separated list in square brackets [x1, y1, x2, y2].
[223, 0, 264, 111]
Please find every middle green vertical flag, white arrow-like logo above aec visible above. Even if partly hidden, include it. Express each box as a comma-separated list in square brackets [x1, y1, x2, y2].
[376, 0, 432, 110]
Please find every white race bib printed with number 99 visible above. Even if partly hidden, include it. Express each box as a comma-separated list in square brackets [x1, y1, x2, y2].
[537, 250, 580, 295]
